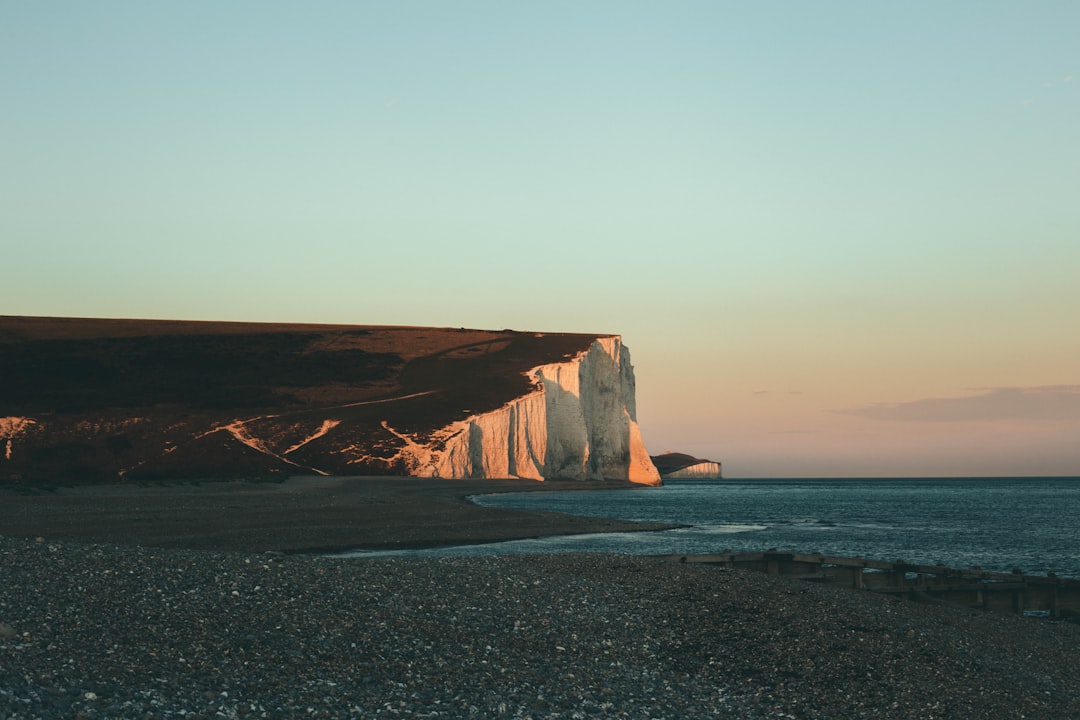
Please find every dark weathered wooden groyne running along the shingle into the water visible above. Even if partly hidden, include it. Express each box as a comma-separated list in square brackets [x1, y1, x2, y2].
[662, 549, 1080, 621]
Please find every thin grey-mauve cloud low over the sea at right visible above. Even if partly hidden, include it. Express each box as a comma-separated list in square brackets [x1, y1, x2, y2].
[840, 385, 1080, 422]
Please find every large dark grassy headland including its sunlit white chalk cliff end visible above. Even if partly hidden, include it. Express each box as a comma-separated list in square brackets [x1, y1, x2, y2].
[0, 315, 661, 485]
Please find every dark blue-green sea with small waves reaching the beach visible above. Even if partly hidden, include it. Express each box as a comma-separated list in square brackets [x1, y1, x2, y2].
[339, 477, 1080, 579]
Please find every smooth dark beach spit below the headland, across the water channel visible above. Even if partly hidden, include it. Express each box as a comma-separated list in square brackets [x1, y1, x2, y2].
[0, 477, 680, 554]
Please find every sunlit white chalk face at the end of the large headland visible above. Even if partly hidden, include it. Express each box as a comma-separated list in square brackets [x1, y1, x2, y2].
[403, 336, 661, 485]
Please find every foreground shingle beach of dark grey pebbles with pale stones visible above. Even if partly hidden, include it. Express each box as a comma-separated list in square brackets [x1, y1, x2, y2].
[6, 538, 1080, 720]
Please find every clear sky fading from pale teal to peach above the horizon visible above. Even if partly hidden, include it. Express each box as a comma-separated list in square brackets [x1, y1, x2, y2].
[0, 0, 1080, 477]
